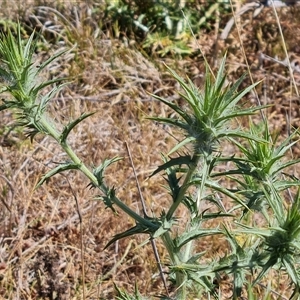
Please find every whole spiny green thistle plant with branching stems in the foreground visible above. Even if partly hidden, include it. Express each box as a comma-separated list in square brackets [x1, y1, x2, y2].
[0, 27, 300, 299]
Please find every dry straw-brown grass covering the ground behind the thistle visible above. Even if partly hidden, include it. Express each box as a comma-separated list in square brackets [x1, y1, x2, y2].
[0, 1, 300, 299]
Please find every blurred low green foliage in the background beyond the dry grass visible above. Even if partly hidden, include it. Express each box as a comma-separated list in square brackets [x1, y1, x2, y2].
[105, 0, 230, 56]
